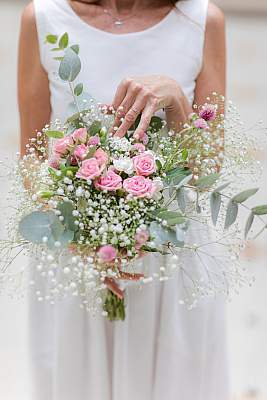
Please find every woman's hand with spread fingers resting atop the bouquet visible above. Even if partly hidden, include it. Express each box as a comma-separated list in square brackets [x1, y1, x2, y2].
[113, 75, 192, 139]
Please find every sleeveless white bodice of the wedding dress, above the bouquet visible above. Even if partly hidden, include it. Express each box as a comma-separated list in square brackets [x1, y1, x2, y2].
[34, 0, 208, 120]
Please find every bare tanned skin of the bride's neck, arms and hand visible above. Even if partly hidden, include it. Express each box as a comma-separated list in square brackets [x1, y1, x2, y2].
[18, 0, 225, 154]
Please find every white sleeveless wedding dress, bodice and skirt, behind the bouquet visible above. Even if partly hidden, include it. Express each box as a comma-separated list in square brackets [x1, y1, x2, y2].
[30, 0, 229, 400]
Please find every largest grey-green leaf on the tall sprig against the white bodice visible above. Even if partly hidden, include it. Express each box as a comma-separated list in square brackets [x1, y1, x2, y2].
[59, 48, 81, 82]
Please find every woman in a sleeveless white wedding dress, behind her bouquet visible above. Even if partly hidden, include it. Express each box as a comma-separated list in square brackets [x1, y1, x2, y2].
[18, 0, 228, 400]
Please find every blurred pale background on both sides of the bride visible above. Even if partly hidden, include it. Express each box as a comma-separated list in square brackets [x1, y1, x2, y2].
[0, 0, 267, 400]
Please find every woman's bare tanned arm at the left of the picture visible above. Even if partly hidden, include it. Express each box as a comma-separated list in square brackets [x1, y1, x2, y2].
[18, 3, 51, 155]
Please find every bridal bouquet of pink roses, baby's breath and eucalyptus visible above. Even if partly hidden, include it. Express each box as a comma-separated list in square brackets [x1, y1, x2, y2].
[0, 34, 267, 320]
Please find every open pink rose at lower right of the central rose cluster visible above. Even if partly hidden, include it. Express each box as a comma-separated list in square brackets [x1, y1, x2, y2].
[123, 176, 155, 197]
